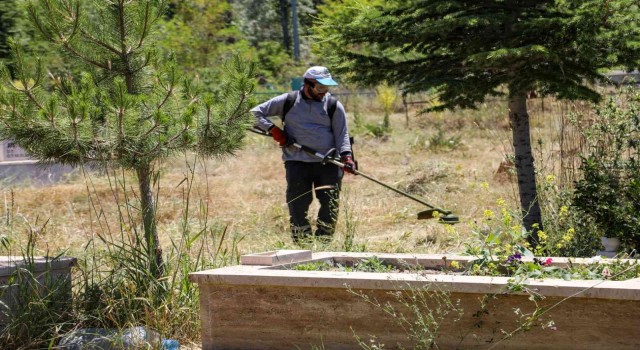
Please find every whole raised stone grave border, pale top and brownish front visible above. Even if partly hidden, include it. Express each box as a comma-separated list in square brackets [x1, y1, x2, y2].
[190, 251, 640, 349]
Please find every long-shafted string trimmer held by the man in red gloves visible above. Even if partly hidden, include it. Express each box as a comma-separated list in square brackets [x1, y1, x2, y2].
[249, 128, 460, 225]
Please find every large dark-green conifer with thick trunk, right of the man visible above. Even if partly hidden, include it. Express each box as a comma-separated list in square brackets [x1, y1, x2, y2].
[317, 0, 640, 244]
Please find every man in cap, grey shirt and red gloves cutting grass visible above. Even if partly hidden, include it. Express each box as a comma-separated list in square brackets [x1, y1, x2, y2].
[251, 66, 355, 243]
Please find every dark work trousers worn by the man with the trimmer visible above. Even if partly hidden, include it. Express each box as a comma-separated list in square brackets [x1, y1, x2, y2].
[284, 161, 344, 242]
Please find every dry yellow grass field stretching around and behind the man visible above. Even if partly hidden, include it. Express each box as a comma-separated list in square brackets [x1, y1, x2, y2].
[0, 95, 592, 253]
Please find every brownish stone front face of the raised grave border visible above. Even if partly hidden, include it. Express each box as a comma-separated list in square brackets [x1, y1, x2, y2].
[200, 284, 640, 350]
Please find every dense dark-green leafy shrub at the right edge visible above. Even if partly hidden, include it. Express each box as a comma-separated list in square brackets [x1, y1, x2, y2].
[573, 92, 640, 249]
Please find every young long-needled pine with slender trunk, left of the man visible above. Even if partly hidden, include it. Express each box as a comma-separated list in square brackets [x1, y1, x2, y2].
[0, 0, 253, 277]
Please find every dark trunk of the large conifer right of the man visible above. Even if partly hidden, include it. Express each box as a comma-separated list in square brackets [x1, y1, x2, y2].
[509, 92, 543, 248]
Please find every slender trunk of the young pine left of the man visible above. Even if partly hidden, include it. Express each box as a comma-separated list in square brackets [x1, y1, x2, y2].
[136, 164, 164, 278]
